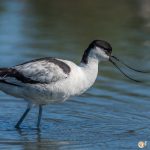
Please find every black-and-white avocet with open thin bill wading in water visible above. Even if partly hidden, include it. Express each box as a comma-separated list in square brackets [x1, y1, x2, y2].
[0, 40, 145, 129]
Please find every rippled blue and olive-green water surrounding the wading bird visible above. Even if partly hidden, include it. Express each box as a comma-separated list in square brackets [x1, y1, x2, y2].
[0, 0, 150, 150]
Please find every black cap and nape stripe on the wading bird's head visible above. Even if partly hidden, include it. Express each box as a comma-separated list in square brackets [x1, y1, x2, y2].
[81, 40, 112, 64]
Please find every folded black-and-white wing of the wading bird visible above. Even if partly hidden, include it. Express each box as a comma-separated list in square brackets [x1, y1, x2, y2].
[0, 57, 70, 84]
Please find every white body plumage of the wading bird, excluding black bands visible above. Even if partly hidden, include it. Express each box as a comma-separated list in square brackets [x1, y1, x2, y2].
[0, 58, 98, 104]
